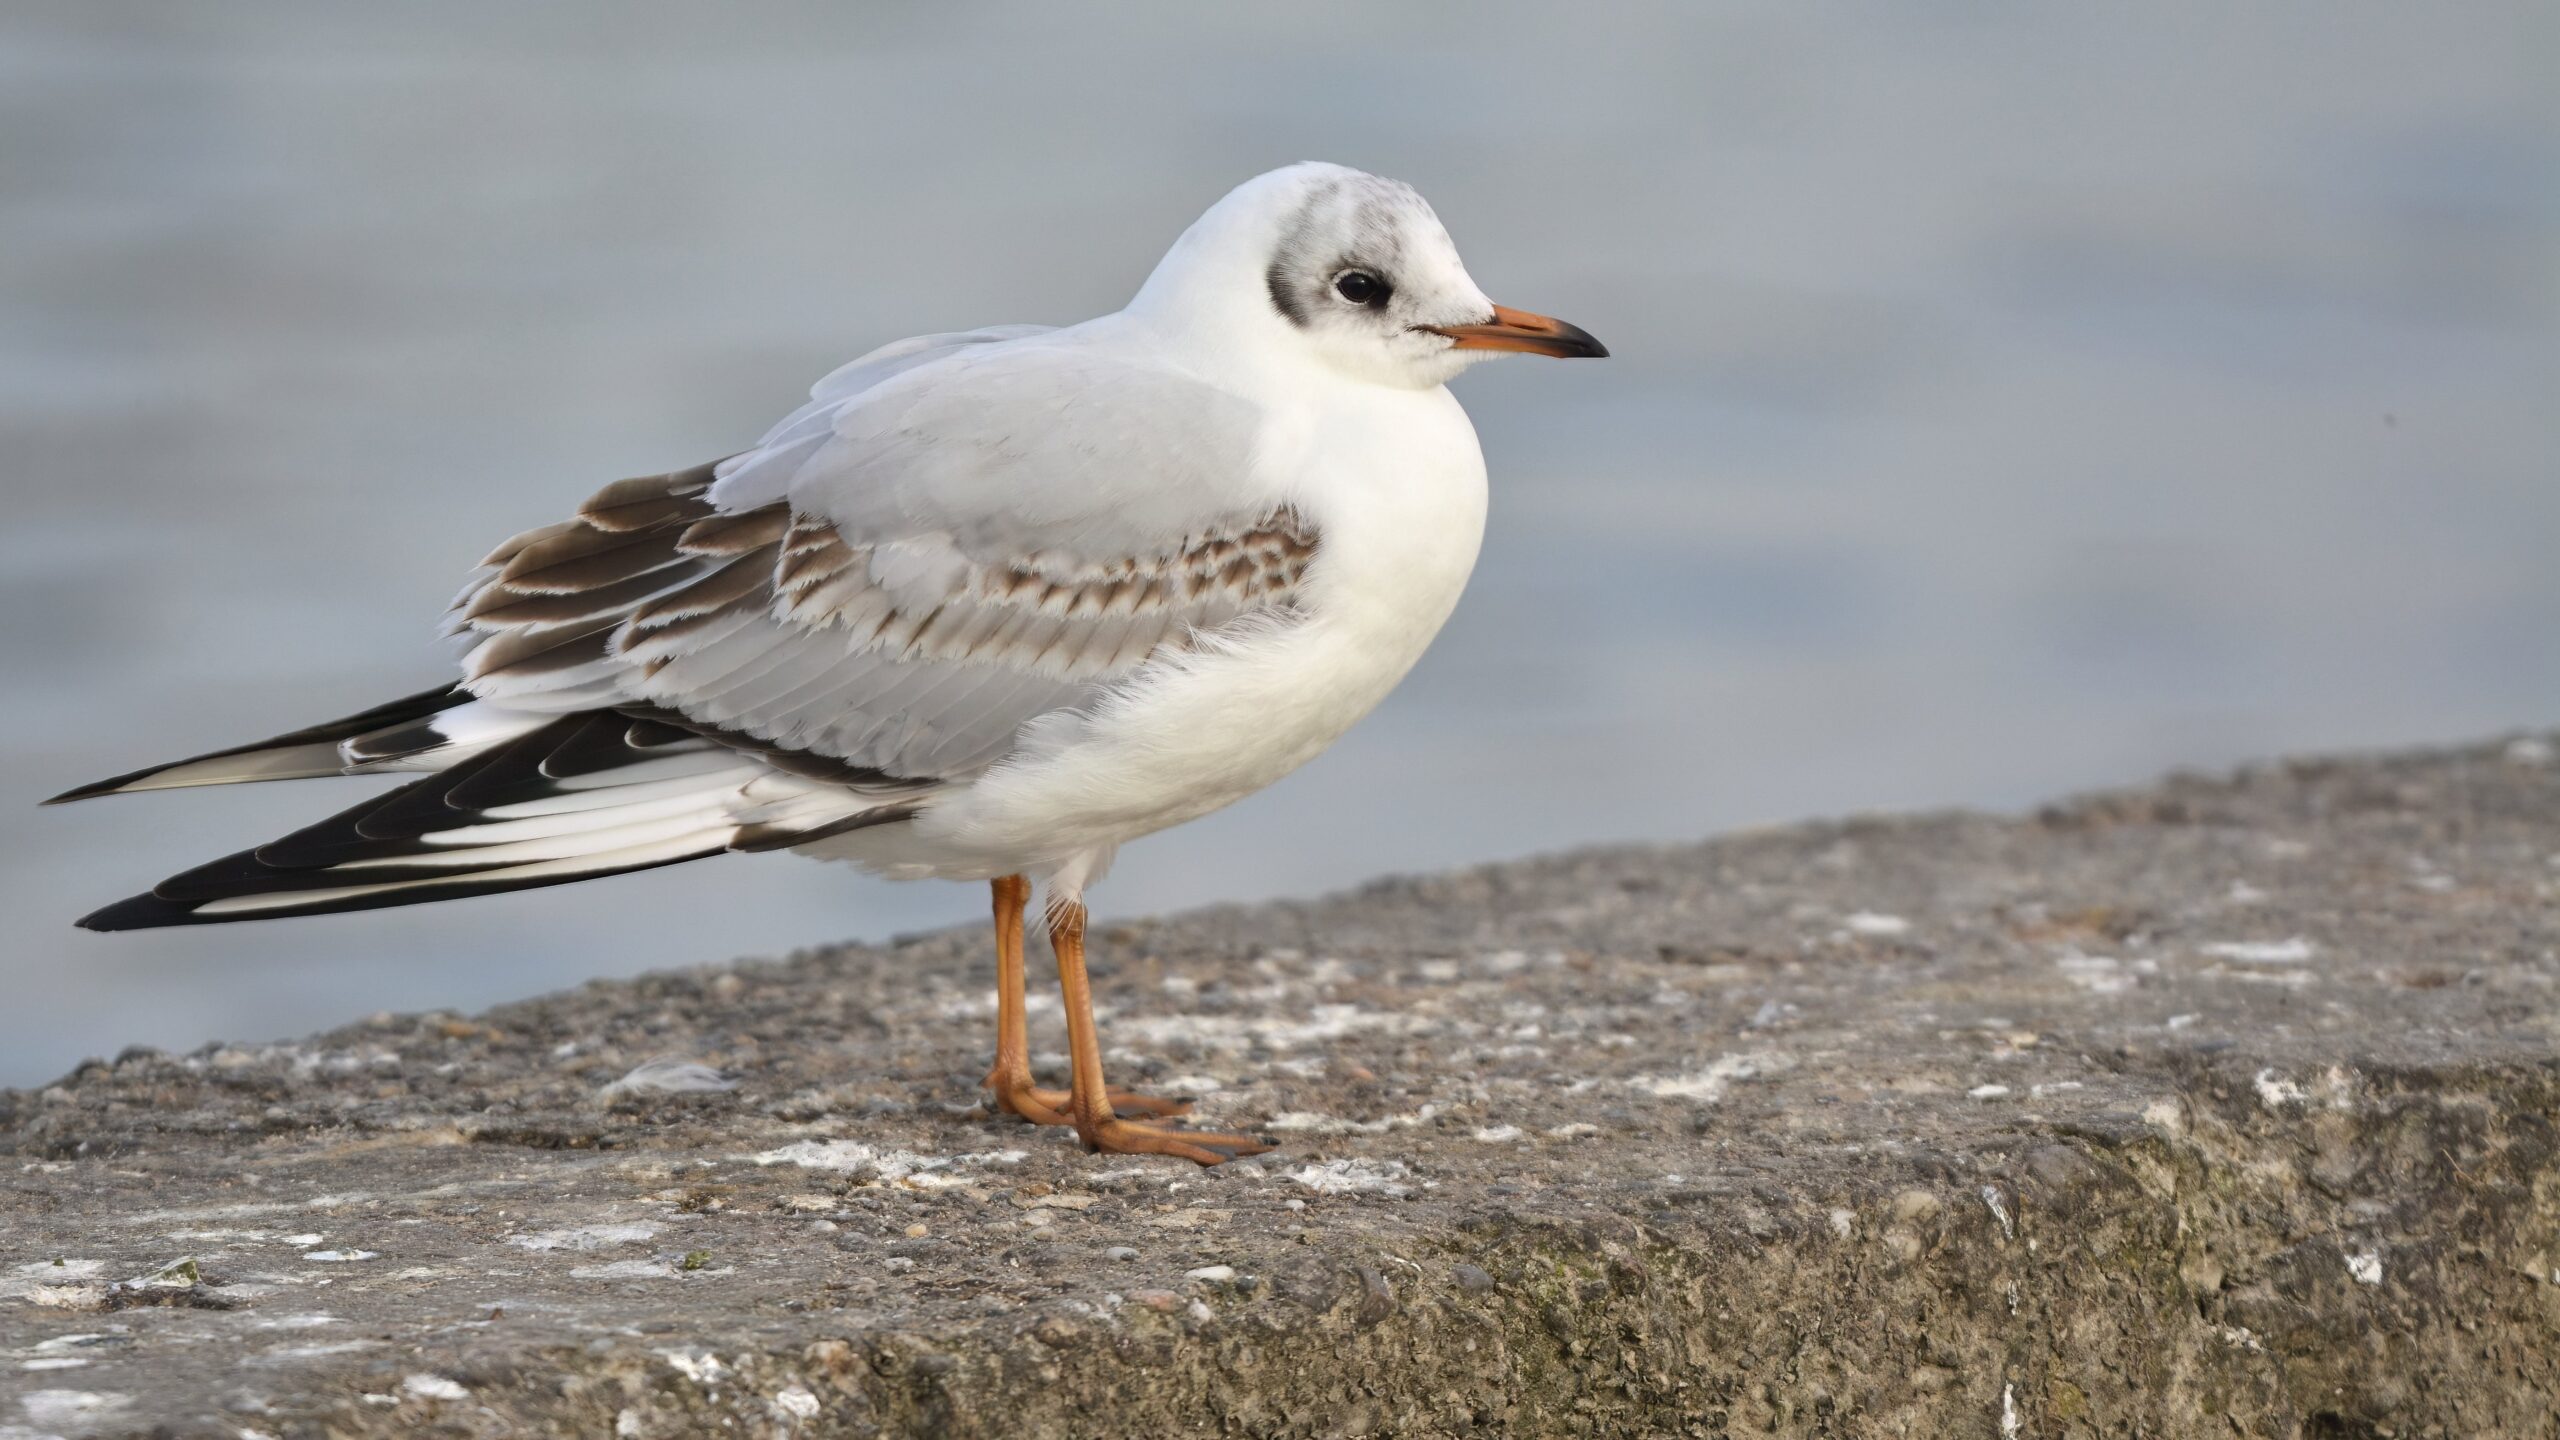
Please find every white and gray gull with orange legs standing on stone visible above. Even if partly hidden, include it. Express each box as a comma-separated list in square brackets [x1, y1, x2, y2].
[54, 161, 1608, 1166]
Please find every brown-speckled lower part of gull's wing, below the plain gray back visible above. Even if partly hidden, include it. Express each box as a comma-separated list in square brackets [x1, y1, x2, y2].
[448, 466, 1318, 779]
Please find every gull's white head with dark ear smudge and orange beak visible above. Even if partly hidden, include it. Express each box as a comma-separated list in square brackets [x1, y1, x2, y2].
[1129, 161, 1608, 389]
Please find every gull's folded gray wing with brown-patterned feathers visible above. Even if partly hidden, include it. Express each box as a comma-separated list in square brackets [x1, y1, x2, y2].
[451, 333, 1316, 779]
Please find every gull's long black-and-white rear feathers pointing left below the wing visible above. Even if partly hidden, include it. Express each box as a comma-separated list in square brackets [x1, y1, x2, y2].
[74, 697, 914, 930]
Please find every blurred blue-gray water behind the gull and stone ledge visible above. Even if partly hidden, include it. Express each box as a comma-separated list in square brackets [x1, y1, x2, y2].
[0, 0, 2560, 1084]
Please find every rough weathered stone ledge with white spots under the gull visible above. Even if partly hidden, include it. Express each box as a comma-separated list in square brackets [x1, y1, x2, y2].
[0, 740, 2560, 1440]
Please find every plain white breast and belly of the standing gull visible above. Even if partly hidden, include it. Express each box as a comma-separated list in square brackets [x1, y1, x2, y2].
[860, 387, 1485, 892]
